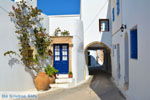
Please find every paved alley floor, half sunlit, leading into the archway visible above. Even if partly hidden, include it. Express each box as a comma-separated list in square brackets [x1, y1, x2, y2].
[38, 73, 125, 100]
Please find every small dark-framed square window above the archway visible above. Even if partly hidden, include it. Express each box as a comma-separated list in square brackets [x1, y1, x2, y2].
[99, 19, 109, 32]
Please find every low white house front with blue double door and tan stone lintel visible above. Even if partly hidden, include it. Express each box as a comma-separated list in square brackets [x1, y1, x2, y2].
[49, 15, 87, 84]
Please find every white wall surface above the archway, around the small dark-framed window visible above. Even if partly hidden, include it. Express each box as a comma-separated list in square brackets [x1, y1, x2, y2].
[81, 0, 111, 48]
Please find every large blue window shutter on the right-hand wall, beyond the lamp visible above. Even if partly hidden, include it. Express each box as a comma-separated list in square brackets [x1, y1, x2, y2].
[130, 28, 138, 59]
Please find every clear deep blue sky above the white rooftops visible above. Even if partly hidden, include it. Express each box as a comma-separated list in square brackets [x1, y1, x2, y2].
[37, 0, 80, 15]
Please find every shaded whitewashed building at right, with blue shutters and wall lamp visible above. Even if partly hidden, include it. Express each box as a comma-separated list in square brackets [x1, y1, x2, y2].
[111, 0, 150, 100]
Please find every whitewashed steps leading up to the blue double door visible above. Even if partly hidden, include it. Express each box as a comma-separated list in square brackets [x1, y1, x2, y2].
[50, 74, 73, 88]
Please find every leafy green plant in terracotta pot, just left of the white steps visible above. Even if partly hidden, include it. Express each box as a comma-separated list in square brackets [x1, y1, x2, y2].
[45, 65, 58, 84]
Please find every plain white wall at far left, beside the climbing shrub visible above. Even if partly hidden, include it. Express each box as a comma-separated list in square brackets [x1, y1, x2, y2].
[0, 0, 34, 91]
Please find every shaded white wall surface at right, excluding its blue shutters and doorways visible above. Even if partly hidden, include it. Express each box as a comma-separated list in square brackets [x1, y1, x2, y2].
[112, 0, 150, 100]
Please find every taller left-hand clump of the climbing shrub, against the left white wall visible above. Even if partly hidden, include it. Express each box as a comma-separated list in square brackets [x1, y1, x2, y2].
[9, 0, 41, 69]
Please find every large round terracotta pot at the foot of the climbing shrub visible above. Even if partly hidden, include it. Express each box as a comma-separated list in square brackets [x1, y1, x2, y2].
[34, 72, 50, 90]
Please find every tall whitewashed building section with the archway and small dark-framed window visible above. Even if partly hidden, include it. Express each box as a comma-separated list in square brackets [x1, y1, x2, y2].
[80, 0, 112, 74]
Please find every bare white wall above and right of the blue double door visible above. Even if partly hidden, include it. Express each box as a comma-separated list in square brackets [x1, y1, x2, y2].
[49, 15, 86, 83]
